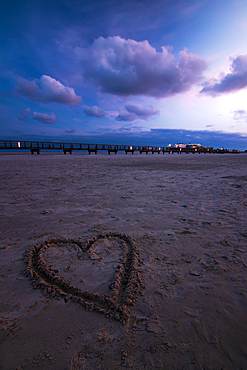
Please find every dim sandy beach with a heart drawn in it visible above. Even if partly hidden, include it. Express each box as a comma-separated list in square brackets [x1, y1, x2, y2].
[0, 152, 247, 370]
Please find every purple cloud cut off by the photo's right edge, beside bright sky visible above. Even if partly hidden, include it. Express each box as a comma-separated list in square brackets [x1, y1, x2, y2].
[200, 54, 247, 96]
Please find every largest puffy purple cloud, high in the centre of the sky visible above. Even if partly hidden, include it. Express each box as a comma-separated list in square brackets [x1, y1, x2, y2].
[83, 36, 207, 98]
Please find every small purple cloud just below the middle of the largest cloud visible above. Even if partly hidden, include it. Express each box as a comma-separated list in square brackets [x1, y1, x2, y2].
[116, 103, 159, 121]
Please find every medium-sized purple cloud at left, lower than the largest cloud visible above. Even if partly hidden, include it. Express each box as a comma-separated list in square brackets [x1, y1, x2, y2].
[14, 75, 82, 105]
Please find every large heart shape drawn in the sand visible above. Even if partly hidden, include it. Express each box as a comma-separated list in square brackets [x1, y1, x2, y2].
[26, 233, 140, 322]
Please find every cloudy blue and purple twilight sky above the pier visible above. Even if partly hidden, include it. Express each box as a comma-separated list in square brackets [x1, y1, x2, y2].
[0, 0, 247, 150]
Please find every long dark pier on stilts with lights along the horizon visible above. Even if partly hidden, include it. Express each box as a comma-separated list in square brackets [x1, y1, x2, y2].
[0, 140, 241, 155]
